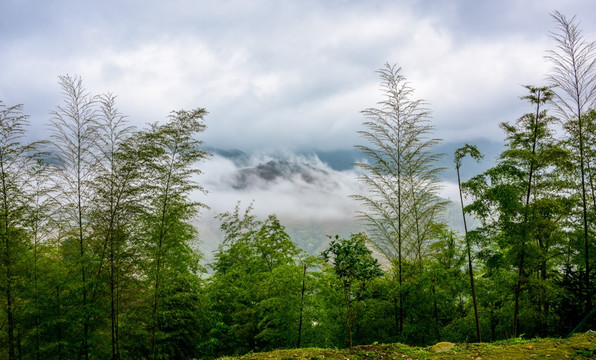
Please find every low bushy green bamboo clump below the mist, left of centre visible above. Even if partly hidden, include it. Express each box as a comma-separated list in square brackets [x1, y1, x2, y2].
[209, 204, 311, 353]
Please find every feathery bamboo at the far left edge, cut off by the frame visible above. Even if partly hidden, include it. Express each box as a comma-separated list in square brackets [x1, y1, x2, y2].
[0, 101, 47, 360]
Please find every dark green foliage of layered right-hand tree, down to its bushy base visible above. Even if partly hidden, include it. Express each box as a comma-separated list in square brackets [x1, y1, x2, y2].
[464, 86, 572, 339]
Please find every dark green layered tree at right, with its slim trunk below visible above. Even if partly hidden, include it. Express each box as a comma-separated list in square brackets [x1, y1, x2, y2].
[462, 86, 569, 336]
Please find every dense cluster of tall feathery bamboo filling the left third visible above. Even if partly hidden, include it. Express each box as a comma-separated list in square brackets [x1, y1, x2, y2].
[0, 76, 211, 359]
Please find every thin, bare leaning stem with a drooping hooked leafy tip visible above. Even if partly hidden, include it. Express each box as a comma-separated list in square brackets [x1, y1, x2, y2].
[454, 144, 483, 342]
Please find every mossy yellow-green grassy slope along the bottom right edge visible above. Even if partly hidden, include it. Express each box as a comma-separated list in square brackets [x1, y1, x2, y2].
[222, 333, 596, 360]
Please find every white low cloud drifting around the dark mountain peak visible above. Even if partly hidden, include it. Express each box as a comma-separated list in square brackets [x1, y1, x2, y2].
[199, 154, 364, 224]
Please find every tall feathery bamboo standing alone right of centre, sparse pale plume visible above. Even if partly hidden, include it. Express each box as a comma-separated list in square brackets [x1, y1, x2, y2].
[352, 64, 444, 335]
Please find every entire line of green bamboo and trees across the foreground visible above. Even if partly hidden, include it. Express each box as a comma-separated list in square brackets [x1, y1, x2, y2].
[0, 13, 596, 360]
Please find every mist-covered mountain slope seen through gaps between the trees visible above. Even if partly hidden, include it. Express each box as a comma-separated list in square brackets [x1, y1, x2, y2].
[197, 147, 478, 260]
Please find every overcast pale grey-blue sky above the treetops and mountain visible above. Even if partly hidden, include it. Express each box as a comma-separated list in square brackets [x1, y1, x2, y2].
[0, 0, 596, 150]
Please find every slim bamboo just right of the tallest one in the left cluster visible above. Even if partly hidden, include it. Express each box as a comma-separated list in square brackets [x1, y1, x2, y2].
[93, 94, 136, 359]
